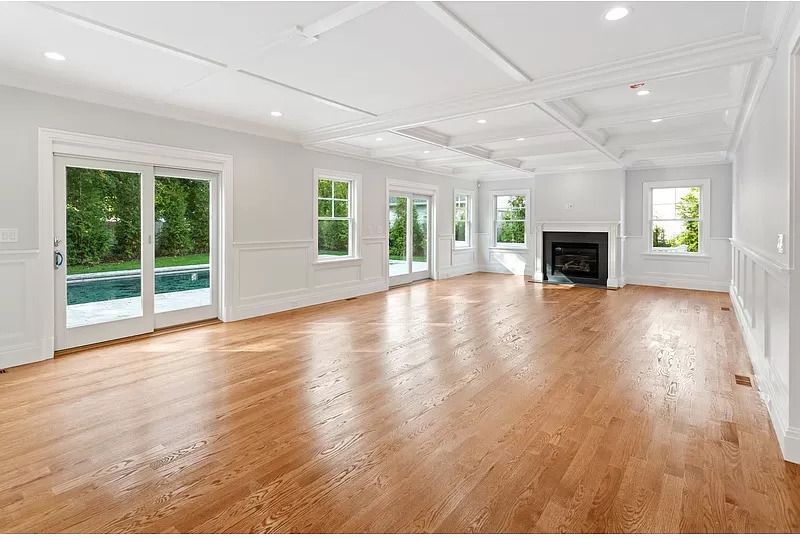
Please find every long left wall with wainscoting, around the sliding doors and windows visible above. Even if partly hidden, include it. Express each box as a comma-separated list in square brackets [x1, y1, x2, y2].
[0, 86, 476, 367]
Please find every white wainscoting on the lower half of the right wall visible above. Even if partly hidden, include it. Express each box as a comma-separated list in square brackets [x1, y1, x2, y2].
[729, 240, 800, 462]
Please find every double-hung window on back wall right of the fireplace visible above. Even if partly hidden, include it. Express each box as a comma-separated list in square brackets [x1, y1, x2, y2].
[645, 180, 708, 254]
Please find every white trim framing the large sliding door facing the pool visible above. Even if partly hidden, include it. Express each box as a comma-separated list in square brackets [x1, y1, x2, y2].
[35, 127, 233, 358]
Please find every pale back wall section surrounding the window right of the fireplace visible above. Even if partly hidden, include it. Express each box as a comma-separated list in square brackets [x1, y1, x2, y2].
[625, 164, 733, 292]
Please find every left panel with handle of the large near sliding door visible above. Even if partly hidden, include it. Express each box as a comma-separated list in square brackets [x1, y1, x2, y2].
[54, 158, 152, 349]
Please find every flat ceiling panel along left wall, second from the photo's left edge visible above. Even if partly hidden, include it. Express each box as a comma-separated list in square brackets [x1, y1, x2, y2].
[169, 70, 372, 131]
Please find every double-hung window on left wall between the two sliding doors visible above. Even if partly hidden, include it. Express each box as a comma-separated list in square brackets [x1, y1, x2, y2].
[316, 174, 355, 260]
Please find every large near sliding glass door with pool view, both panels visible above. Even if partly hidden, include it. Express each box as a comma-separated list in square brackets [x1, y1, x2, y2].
[53, 157, 217, 350]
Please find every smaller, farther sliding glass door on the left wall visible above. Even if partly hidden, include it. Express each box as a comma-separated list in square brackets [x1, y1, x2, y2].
[389, 192, 431, 285]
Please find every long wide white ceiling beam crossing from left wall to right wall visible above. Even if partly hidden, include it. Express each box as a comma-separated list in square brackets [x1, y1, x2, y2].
[303, 36, 776, 143]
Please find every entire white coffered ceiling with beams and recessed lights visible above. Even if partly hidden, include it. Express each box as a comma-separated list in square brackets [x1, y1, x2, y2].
[0, 1, 792, 180]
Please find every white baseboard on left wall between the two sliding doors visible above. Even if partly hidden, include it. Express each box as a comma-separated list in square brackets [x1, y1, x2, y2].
[228, 278, 389, 321]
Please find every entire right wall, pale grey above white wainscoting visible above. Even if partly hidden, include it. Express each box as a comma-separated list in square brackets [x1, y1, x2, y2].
[730, 10, 800, 462]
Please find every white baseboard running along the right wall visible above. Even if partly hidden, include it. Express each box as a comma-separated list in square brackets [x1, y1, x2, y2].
[728, 285, 800, 463]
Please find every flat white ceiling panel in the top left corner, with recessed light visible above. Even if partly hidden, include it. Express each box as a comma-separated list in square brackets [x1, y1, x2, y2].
[0, 2, 216, 99]
